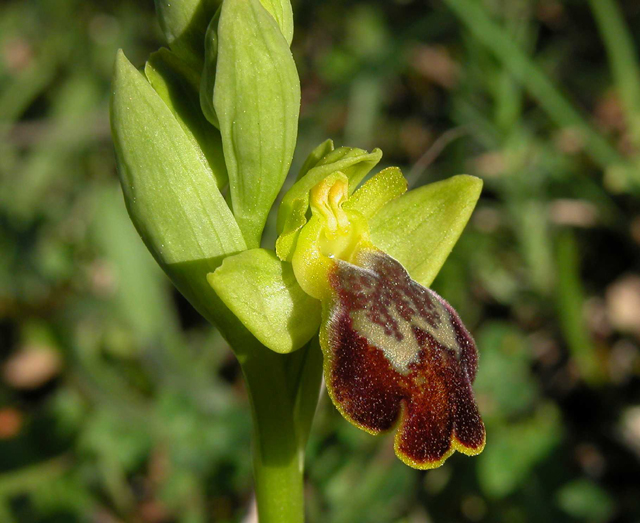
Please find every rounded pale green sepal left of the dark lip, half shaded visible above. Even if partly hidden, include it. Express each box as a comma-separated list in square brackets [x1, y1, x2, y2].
[207, 249, 320, 354]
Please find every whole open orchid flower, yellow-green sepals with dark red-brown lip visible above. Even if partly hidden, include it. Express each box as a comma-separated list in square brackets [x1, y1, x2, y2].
[209, 142, 485, 469]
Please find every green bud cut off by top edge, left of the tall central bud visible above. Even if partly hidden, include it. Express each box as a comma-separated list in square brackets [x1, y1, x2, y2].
[155, 0, 219, 70]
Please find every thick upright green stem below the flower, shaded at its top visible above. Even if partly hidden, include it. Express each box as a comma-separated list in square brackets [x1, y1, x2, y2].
[237, 342, 322, 523]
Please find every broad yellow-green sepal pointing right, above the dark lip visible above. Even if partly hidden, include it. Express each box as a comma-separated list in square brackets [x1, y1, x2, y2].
[369, 175, 482, 286]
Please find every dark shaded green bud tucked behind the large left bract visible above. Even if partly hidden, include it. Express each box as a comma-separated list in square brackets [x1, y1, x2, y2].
[144, 48, 228, 187]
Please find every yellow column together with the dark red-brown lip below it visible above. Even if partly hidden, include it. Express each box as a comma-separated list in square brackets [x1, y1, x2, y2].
[292, 171, 485, 469]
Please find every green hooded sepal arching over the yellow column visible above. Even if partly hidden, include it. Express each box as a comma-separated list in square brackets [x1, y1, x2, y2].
[276, 146, 382, 261]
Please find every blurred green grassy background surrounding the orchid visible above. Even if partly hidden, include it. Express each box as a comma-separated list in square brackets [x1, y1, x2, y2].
[0, 0, 640, 523]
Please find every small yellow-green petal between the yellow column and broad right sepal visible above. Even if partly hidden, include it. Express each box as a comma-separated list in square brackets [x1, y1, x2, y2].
[344, 167, 407, 219]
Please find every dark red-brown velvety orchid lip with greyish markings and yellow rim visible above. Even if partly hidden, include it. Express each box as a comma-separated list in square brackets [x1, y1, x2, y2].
[321, 249, 485, 469]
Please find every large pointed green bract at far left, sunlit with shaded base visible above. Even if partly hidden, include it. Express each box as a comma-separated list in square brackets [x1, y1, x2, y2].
[111, 51, 246, 324]
